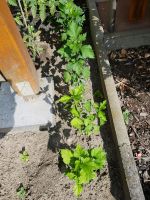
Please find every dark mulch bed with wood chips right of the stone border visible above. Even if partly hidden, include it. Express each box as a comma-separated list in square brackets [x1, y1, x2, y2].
[109, 46, 150, 199]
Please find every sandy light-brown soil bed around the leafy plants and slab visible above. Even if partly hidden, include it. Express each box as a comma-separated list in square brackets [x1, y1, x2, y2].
[0, 0, 124, 200]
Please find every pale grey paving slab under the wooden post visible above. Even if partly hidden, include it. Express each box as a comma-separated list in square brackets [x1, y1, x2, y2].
[0, 77, 55, 133]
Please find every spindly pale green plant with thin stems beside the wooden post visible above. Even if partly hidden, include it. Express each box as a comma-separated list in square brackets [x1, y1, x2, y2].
[8, 0, 46, 61]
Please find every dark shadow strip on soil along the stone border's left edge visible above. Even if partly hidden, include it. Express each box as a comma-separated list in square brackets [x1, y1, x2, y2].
[89, 56, 123, 200]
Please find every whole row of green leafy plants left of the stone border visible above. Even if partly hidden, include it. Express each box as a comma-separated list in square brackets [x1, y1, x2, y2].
[9, 0, 107, 196]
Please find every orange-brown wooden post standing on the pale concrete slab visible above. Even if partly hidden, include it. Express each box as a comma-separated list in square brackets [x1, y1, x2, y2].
[0, 0, 39, 96]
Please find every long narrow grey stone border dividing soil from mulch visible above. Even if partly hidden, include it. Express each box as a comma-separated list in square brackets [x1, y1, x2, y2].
[87, 0, 145, 200]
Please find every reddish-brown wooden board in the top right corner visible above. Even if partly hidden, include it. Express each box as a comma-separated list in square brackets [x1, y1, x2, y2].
[115, 0, 150, 32]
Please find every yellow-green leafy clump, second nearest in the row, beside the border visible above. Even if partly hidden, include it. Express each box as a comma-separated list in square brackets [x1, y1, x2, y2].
[59, 85, 107, 136]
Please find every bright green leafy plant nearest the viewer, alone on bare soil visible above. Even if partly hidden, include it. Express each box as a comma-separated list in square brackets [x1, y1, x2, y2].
[61, 145, 106, 196]
